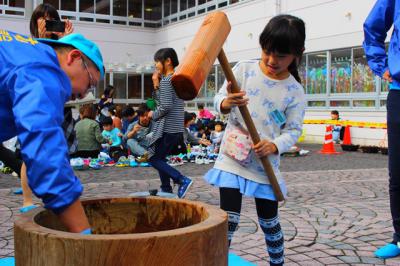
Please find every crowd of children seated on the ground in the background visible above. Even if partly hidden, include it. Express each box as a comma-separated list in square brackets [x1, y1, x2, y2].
[67, 101, 225, 169]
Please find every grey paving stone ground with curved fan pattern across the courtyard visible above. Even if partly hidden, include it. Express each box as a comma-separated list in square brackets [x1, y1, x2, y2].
[0, 145, 400, 266]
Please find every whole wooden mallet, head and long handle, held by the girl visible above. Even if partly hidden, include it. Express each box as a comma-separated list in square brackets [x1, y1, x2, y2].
[171, 12, 285, 201]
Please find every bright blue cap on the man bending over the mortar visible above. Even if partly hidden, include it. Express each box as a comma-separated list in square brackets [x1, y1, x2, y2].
[37, 33, 104, 78]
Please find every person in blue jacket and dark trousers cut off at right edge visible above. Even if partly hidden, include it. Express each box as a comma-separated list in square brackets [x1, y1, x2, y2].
[364, 0, 400, 258]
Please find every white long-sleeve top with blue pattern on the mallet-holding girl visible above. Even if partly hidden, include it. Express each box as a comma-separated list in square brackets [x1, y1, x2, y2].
[214, 60, 305, 184]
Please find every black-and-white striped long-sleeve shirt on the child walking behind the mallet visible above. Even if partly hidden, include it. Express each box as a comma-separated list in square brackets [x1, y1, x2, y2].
[149, 74, 184, 156]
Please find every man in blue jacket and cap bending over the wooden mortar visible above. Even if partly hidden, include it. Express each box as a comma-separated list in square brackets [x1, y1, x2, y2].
[0, 29, 104, 233]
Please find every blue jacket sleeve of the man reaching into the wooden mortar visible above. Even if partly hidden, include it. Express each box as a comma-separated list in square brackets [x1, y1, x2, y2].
[8, 64, 83, 213]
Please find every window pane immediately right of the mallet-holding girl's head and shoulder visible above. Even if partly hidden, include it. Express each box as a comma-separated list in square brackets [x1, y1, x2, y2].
[307, 52, 327, 94]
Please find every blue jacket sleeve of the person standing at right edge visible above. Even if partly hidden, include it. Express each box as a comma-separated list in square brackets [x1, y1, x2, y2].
[363, 0, 395, 77]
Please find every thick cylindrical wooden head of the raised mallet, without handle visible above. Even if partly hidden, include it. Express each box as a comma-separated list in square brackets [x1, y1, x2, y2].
[171, 11, 231, 100]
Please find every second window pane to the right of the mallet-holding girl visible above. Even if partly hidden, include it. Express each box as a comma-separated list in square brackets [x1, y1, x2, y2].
[331, 49, 351, 93]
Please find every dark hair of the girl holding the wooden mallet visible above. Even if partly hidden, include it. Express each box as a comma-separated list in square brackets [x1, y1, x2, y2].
[259, 15, 306, 82]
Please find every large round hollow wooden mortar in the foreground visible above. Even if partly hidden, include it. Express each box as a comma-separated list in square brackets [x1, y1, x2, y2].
[14, 197, 228, 266]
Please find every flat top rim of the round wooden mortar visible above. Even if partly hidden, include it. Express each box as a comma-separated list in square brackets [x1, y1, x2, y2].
[14, 197, 227, 240]
